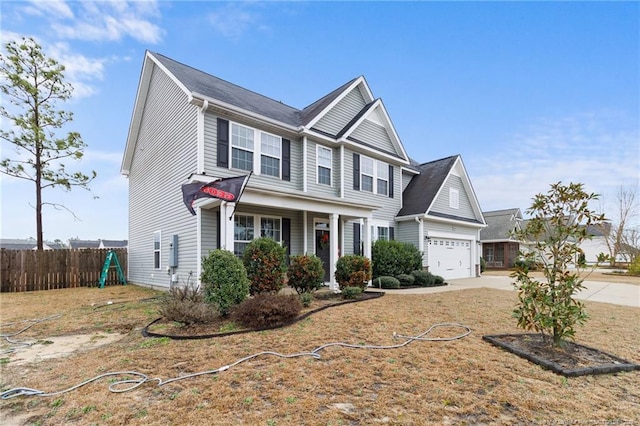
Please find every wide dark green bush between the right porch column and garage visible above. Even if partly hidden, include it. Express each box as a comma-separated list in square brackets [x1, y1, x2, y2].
[371, 240, 422, 277]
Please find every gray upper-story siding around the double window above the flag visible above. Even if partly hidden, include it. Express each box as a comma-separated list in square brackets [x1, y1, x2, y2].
[204, 113, 302, 191]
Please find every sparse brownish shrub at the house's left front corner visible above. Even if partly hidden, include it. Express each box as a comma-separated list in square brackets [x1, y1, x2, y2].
[158, 285, 216, 325]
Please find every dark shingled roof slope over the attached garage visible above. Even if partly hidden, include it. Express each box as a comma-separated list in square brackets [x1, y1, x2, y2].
[398, 155, 459, 216]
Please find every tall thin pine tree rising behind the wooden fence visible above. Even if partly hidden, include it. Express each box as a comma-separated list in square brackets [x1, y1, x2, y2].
[0, 38, 96, 250]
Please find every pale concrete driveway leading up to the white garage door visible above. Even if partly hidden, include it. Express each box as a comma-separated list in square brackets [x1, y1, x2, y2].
[368, 275, 640, 308]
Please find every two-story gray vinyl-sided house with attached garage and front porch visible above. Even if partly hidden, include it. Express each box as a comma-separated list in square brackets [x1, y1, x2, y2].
[121, 52, 485, 288]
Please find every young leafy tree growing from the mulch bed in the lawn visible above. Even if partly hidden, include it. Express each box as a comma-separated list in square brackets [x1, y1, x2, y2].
[511, 182, 605, 346]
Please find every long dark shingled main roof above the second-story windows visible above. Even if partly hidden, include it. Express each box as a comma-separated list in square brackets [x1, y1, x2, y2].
[150, 52, 356, 127]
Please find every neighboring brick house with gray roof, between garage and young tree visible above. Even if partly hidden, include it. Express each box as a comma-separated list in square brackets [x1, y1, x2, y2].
[480, 208, 522, 269]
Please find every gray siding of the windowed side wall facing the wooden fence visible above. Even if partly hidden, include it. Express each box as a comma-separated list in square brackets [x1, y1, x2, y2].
[128, 68, 197, 287]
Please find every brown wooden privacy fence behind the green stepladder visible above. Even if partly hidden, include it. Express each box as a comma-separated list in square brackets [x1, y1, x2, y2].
[0, 249, 127, 293]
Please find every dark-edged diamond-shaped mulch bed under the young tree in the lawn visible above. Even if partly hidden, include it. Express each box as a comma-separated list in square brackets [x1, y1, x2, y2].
[482, 334, 640, 377]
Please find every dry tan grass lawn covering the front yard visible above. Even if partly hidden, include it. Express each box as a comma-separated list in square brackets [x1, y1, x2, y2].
[0, 285, 640, 425]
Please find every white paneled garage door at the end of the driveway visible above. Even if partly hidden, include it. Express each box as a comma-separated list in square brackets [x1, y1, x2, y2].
[429, 238, 471, 279]
